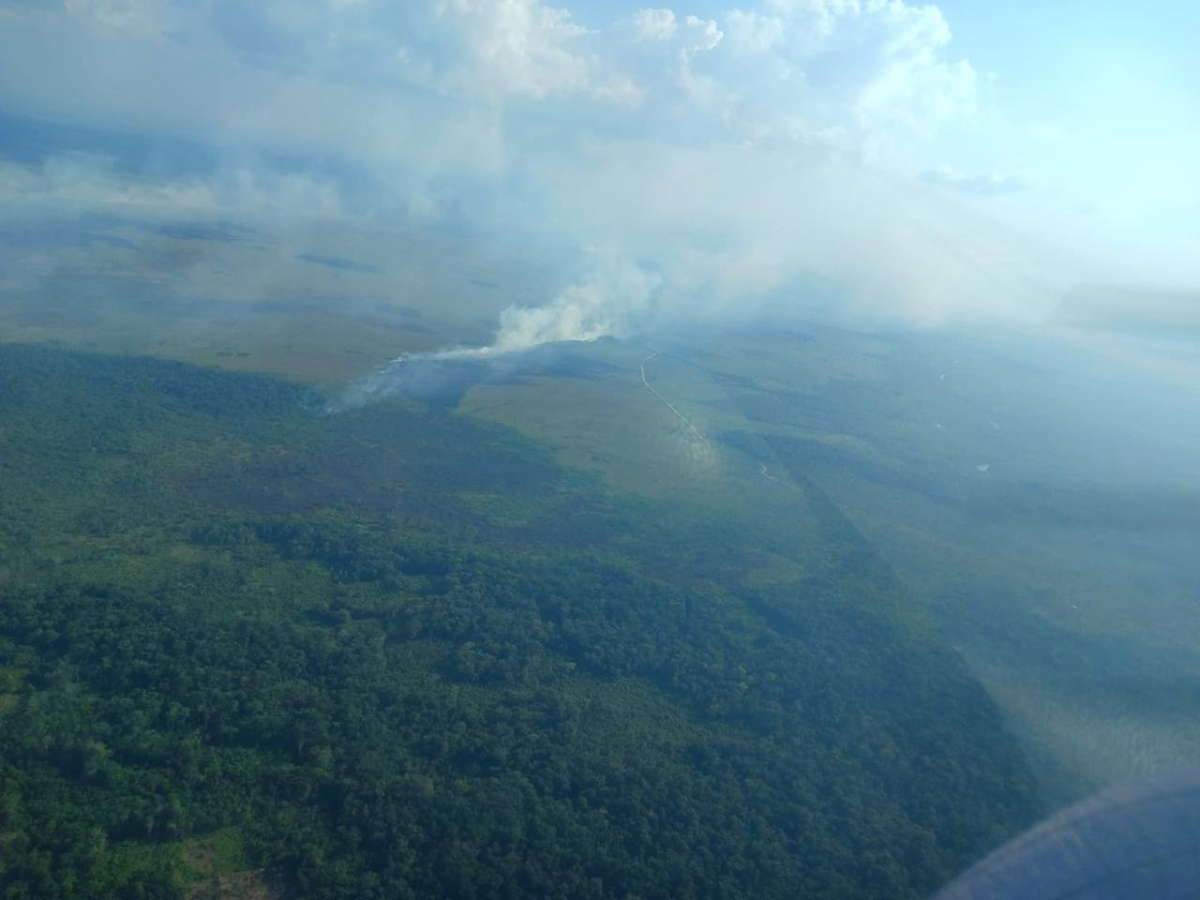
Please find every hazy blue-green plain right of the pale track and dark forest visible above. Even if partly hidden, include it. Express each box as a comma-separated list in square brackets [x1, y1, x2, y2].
[665, 331, 1200, 805]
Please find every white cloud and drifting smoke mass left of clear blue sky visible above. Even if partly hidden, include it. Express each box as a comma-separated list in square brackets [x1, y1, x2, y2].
[0, 0, 1180, 343]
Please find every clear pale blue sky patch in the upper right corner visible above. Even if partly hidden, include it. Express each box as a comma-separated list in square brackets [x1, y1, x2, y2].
[943, 0, 1200, 204]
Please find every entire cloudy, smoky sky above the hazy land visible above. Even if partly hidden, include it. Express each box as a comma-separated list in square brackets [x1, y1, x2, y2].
[0, 0, 1200, 347]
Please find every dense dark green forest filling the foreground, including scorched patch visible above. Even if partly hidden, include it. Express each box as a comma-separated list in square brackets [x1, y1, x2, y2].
[0, 346, 1038, 900]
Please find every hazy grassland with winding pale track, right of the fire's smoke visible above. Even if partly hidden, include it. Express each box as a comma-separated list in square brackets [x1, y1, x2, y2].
[458, 326, 1200, 805]
